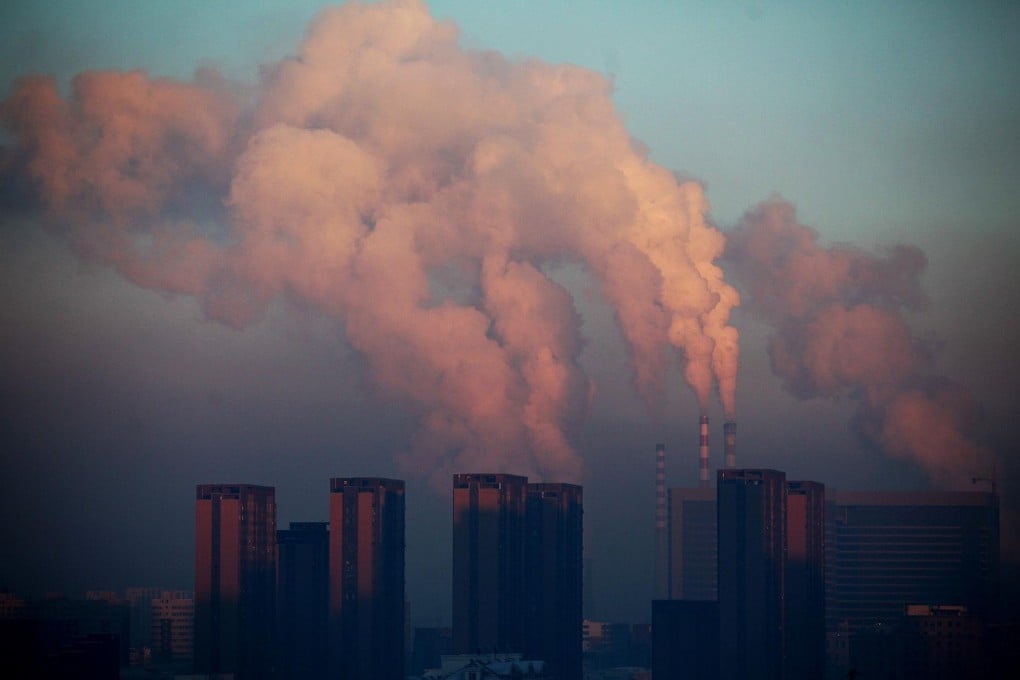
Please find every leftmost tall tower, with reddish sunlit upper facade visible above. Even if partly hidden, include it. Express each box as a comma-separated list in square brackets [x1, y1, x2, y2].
[195, 484, 276, 679]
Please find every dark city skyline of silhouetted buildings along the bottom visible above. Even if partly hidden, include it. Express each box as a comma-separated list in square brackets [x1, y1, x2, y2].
[0, 468, 999, 678]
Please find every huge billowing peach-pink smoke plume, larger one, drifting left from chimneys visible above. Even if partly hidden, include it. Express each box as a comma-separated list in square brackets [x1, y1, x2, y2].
[0, 0, 742, 487]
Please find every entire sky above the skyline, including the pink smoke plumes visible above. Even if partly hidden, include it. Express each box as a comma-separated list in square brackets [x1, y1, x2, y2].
[0, 1, 1020, 624]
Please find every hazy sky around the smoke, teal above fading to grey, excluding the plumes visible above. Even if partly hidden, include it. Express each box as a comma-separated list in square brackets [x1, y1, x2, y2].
[0, 1, 1020, 623]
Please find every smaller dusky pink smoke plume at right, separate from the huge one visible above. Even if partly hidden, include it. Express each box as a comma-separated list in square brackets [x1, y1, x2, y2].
[726, 199, 988, 487]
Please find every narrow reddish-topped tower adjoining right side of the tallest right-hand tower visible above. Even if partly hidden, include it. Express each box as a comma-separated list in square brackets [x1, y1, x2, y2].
[785, 481, 825, 680]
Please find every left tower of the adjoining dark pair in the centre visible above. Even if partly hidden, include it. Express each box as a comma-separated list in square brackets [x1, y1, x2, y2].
[453, 474, 527, 653]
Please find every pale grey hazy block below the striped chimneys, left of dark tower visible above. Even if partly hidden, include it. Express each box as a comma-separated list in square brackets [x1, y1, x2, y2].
[669, 487, 718, 600]
